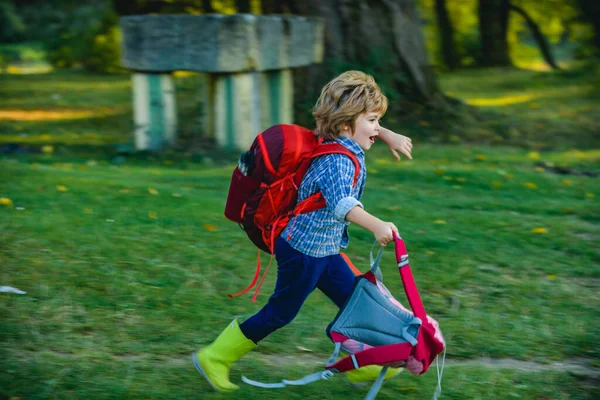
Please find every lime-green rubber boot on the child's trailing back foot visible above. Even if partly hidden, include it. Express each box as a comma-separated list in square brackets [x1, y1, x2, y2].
[192, 320, 256, 392]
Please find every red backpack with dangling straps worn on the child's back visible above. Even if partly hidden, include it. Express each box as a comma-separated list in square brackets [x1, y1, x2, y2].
[225, 124, 360, 302]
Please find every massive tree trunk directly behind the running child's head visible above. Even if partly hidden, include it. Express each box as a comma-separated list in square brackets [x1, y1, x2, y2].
[292, 0, 445, 126]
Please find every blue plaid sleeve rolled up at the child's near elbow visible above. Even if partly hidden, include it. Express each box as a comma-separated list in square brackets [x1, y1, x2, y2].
[316, 154, 364, 222]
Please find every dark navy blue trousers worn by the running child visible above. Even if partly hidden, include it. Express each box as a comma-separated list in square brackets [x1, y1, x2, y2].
[240, 237, 356, 343]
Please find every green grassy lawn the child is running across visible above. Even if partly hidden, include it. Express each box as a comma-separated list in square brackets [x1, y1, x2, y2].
[0, 66, 600, 400]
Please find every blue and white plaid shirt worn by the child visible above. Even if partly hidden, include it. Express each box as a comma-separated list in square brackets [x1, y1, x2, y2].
[281, 136, 367, 257]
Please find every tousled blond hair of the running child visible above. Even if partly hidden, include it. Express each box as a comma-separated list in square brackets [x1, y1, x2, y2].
[312, 71, 388, 140]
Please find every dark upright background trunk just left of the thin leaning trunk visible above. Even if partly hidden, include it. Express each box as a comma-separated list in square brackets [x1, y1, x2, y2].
[478, 0, 512, 67]
